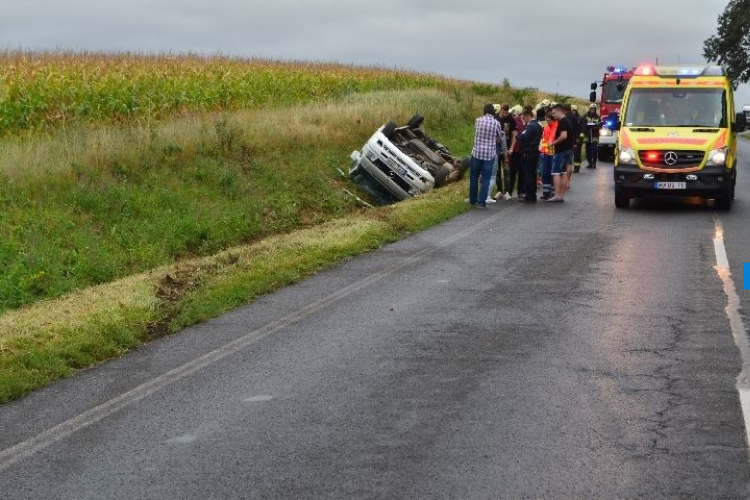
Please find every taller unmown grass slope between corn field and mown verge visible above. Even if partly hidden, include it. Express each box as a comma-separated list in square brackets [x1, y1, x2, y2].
[0, 90, 481, 313]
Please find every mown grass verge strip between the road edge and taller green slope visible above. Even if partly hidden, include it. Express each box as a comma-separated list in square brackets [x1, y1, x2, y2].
[0, 183, 466, 403]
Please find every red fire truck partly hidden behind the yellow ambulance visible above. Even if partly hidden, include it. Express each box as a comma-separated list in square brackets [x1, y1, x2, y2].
[591, 66, 633, 161]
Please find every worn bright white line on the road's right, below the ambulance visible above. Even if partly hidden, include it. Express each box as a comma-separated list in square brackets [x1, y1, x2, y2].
[714, 215, 750, 460]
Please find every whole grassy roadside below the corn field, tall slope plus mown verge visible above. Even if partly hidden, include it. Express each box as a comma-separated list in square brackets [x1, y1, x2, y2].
[0, 85, 483, 402]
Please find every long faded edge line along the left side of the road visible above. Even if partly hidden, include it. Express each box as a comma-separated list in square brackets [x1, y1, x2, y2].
[0, 206, 518, 472]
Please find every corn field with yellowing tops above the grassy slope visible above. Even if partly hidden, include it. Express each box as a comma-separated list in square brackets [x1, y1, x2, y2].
[0, 51, 468, 135]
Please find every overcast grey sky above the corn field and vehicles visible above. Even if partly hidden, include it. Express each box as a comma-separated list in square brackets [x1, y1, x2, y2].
[0, 0, 750, 105]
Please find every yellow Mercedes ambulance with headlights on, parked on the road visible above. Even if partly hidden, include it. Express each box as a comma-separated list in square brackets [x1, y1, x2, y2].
[605, 66, 746, 210]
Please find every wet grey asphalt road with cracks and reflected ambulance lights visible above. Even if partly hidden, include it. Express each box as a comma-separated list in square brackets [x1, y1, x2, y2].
[0, 142, 750, 500]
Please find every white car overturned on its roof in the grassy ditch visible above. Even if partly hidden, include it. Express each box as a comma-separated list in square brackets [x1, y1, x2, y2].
[349, 115, 468, 201]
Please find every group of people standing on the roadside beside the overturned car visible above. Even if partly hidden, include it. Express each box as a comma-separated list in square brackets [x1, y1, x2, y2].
[466, 99, 600, 209]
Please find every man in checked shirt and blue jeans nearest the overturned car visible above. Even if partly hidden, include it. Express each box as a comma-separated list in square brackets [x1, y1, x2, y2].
[469, 104, 502, 208]
